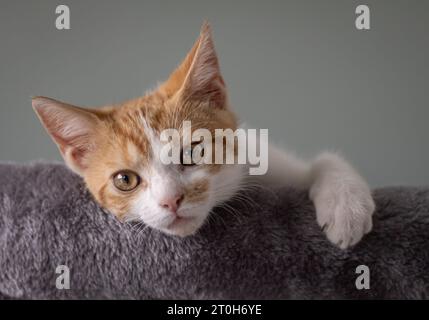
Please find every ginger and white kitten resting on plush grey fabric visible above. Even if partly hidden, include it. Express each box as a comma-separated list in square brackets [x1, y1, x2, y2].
[32, 25, 374, 248]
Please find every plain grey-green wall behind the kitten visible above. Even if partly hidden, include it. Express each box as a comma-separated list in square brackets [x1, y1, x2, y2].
[0, 0, 429, 186]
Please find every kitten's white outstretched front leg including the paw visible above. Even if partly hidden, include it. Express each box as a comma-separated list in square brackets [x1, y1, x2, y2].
[254, 146, 375, 249]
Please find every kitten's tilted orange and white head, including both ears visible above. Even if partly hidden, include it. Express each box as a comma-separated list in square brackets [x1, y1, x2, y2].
[33, 25, 242, 236]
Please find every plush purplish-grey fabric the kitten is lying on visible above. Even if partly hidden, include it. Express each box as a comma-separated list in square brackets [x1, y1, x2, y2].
[0, 163, 429, 299]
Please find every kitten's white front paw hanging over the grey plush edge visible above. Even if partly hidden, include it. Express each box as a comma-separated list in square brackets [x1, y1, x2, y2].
[310, 179, 375, 249]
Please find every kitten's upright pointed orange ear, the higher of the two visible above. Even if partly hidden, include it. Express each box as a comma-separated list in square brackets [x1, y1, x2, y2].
[160, 23, 227, 108]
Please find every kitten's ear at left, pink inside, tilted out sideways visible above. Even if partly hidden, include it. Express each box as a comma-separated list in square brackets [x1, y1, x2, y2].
[32, 97, 99, 174]
